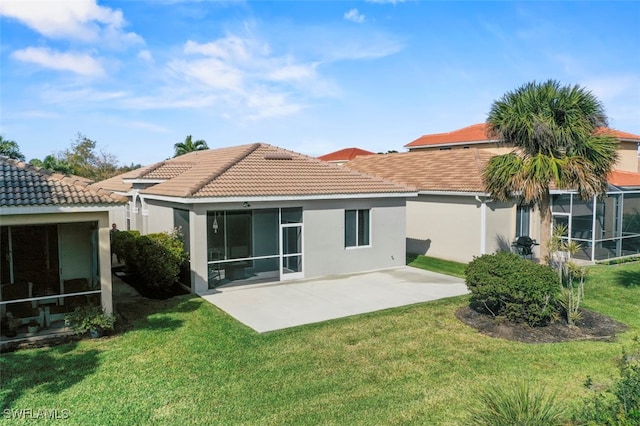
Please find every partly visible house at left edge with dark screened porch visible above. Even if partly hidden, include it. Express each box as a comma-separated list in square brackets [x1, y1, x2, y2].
[0, 156, 126, 340]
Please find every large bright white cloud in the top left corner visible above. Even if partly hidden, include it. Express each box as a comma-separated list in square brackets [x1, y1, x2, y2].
[0, 0, 142, 46]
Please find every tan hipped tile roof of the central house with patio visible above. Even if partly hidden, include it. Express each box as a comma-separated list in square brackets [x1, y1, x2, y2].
[94, 143, 415, 198]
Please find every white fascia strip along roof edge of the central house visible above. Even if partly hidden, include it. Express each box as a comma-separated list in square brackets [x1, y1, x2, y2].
[140, 192, 418, 204]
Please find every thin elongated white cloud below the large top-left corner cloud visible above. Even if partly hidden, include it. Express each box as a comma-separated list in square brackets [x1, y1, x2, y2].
[11, 47, 104, 77]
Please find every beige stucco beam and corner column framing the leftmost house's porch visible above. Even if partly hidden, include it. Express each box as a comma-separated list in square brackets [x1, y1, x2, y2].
[0, 208, 113, 313]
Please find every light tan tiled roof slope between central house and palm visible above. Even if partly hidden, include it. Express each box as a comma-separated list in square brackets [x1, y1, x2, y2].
[344, 148, 494, 193]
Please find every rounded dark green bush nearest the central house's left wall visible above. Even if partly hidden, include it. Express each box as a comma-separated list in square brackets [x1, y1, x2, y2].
[135, 232, 186, 292]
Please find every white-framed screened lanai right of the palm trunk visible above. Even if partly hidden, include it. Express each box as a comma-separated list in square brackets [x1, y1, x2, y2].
[552, 185, 640, 261]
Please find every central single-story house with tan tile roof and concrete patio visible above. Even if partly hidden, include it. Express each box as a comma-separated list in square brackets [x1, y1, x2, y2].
[93, 143, 417, 293]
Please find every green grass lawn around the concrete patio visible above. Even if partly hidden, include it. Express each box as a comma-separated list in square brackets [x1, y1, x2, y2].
[0, 263, 640, 425]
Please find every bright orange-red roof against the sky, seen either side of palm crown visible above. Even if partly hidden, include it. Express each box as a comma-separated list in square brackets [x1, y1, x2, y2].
[405, 123, 640, 148]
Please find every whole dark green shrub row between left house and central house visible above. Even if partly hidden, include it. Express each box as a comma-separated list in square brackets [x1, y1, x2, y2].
[113, 231, 187, 291]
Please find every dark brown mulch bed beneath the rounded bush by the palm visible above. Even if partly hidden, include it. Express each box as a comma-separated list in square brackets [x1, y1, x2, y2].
[455, 306, 627, 343]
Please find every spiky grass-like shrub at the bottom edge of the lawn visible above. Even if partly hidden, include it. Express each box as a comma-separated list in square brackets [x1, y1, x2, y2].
[469, 382, 566, 426]
